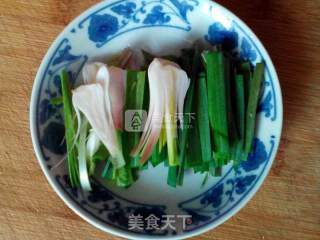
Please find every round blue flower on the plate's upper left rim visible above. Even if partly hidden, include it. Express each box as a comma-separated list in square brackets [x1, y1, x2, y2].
[88, 14, 119, 43]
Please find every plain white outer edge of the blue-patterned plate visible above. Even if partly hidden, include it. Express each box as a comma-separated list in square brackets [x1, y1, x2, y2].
[29, 0, 283, 240]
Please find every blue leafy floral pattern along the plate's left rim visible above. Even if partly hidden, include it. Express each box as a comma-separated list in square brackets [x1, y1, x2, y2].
[37, 39, 87, 165]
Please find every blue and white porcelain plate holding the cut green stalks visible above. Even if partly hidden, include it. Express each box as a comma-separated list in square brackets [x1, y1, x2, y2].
[30, 0, 282, 239]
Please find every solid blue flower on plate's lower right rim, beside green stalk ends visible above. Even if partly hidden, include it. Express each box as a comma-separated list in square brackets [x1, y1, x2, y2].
[241, 138, 268, 172]
